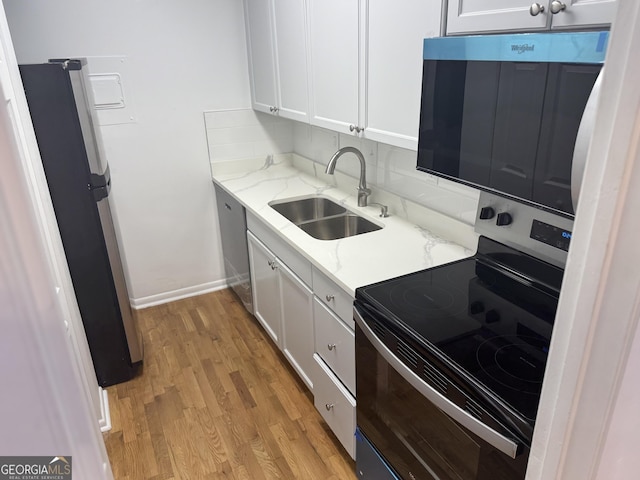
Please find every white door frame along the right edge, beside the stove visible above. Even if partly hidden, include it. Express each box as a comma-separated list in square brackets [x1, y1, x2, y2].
[527, 1, 640, 480]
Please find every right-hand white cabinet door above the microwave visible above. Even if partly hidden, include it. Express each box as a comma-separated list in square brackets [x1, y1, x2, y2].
[551, 0, 616, 28]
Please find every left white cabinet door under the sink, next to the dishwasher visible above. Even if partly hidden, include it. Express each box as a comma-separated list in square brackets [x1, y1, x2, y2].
[247, 232, 282, 350]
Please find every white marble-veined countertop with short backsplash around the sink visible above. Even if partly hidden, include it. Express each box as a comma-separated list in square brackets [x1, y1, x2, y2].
[212, 155, 477, 297]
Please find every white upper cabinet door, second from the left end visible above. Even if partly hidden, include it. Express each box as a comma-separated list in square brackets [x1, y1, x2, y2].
[273, 0, 309, 122]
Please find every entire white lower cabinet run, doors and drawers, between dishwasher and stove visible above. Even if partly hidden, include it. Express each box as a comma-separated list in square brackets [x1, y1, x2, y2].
[247, 218, 356, 458]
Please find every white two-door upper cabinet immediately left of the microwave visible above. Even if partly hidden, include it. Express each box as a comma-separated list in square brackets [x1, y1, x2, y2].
[309, 0, 441, 150]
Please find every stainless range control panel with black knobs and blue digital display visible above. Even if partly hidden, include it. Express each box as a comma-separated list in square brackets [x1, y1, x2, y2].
[475, 192, 573, 268]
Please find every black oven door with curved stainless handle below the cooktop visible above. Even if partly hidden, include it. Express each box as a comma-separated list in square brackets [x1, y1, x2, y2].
[354, 305, 529, 480]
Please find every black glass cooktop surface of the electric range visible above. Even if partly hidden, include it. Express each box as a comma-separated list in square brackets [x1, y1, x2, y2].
[356, 237, 563, 422]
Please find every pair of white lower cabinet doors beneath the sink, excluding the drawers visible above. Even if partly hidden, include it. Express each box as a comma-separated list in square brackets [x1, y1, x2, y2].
[247, 232, 314, 392]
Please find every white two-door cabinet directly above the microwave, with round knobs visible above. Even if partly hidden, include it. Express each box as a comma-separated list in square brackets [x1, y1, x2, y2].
[447, 0, 615, 35]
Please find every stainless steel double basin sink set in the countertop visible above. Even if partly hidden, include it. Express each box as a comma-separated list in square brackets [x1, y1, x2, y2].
[269, 196, 382, 240]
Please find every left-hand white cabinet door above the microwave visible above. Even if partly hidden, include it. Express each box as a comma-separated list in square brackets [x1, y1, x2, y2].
[447, 0, 551, 35]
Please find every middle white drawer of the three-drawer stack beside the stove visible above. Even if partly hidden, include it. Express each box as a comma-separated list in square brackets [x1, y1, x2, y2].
[313, 297, 356, 396]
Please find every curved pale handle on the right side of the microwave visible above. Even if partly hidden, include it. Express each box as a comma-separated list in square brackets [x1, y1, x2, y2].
[571, 68, 604, 212]
